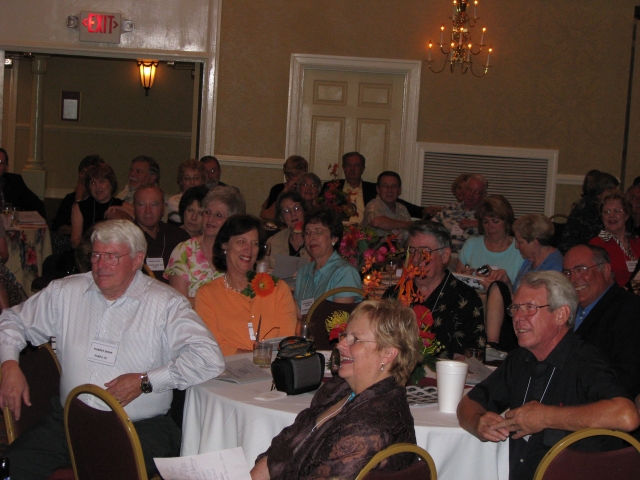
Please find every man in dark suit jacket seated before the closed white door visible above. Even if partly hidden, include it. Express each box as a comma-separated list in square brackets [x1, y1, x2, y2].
[320, 152, 425, 223]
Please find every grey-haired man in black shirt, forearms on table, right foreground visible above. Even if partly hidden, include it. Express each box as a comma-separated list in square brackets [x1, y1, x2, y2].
[457, 271, 640, 480]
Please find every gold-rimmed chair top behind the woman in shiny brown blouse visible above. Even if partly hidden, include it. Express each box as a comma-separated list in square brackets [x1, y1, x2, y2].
[356, 443, 438, 480]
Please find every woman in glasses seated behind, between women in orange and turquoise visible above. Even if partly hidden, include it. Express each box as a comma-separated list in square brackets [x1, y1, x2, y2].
[267, 192, 311, 268]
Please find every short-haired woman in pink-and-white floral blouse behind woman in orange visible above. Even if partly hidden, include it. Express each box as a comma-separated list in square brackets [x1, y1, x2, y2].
[164, 187, 247, 306]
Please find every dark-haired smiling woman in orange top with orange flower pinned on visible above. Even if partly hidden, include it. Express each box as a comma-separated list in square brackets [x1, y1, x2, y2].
[195, 215, 296, 355]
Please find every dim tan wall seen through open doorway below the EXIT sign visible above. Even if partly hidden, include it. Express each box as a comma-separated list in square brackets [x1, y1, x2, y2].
[12, 56, 194, 196]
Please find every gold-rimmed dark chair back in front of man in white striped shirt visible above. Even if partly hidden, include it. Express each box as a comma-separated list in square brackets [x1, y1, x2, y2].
[64, 384, 147, 480]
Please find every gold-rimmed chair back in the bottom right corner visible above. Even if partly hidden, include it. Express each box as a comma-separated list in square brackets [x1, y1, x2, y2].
[533, 428, 640, 480]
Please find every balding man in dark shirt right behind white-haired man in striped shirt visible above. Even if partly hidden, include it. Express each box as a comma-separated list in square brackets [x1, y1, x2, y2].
[133, 184, 191, 285]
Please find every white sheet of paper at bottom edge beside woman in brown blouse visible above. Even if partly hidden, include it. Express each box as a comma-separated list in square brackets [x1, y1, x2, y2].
[153, 447, 251, 480]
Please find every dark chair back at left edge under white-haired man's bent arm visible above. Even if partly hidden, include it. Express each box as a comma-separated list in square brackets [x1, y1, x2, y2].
[3, 343, 60, 443]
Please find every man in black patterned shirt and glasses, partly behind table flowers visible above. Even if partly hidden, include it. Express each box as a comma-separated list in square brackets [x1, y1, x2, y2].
[384, 222, 487, 359]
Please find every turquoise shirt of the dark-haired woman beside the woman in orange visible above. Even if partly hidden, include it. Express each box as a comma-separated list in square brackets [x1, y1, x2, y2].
[295, 251, 362, 307]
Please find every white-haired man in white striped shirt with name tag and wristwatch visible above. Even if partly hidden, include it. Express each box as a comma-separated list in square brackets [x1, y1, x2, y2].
[0, 220, 225, 478]
